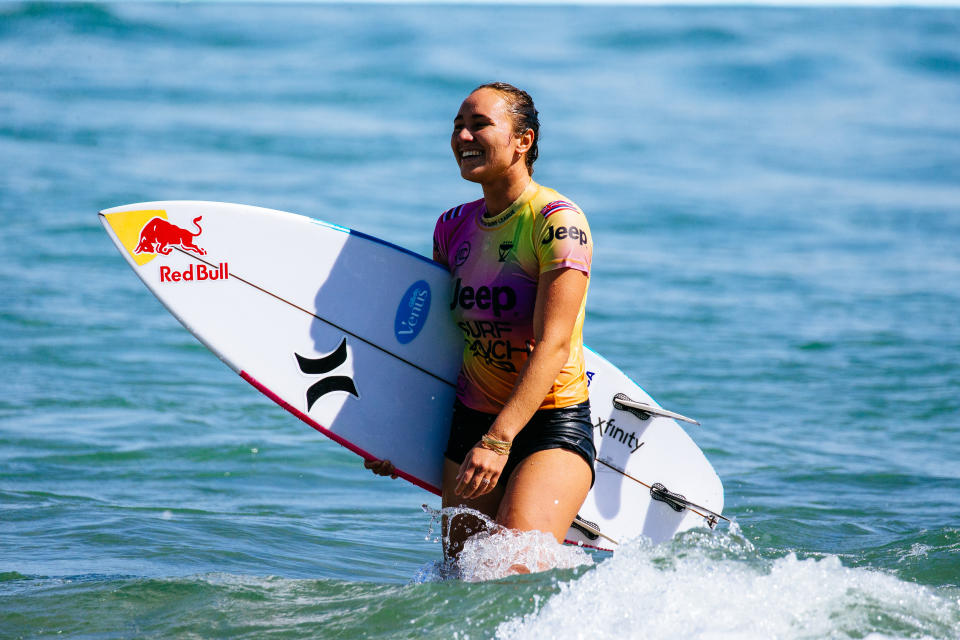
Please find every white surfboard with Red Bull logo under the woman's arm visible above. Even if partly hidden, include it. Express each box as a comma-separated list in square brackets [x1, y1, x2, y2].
[100, 201, 723, 550]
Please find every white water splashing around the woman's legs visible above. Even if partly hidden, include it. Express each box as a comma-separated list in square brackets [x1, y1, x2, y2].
[414, 505, 593, 582]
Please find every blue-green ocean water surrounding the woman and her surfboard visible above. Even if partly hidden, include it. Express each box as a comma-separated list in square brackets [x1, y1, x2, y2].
[0, 2, 960, 640]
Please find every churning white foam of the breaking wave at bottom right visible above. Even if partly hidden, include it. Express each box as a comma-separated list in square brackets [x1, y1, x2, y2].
[496, 531, 960, 640]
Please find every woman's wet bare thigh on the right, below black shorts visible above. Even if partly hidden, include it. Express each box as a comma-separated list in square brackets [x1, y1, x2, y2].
[496, 448, 593, 542]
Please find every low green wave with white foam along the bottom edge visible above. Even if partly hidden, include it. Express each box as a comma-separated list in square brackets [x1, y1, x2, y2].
[7, 523, 960, 640]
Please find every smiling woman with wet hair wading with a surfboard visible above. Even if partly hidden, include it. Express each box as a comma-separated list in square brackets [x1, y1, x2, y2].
[366, 83, 596, 557]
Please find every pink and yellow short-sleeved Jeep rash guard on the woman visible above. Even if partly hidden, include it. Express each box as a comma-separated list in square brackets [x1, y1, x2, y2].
[433, 181, 593, 413]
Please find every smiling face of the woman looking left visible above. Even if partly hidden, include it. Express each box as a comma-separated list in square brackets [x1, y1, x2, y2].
[450, 89, 532, 184]
